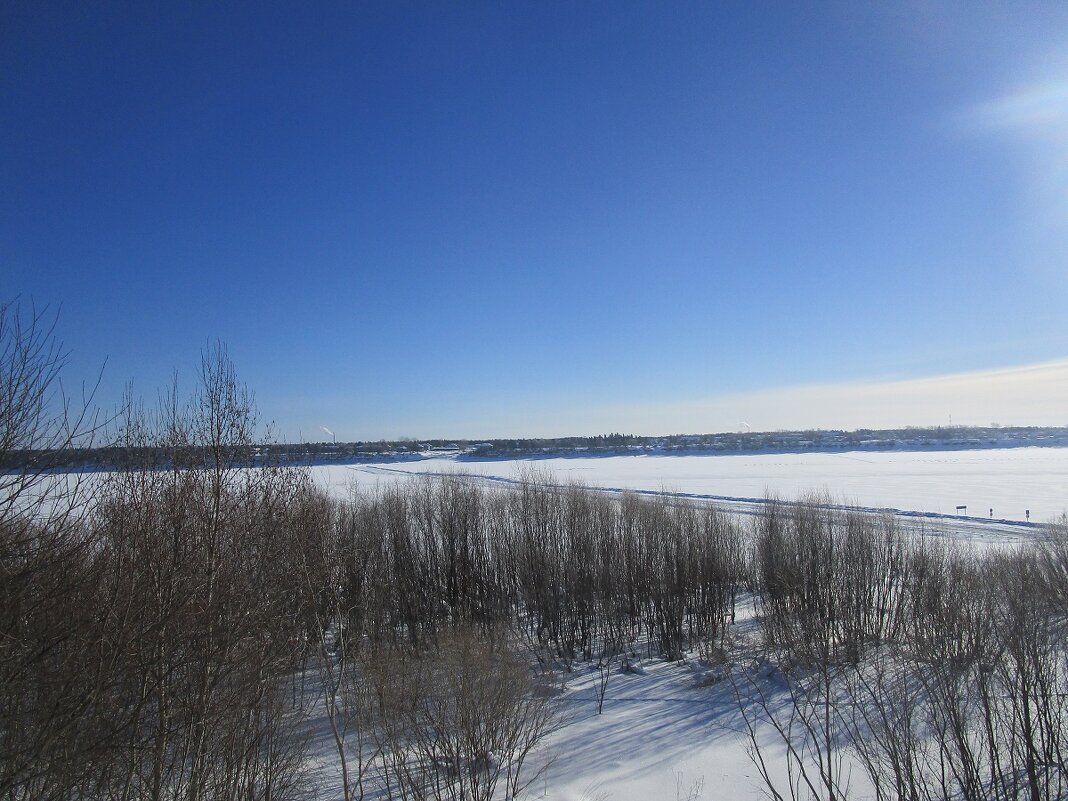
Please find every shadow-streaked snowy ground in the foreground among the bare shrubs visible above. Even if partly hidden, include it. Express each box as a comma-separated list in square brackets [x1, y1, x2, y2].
[305, 609, 815, 801]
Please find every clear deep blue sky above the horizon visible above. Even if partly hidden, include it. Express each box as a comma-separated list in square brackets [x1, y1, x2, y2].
[0, 2, 1068, 440]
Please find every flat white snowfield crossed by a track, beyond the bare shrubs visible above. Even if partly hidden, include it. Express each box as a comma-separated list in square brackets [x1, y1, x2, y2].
[314, 447, 1068, 522]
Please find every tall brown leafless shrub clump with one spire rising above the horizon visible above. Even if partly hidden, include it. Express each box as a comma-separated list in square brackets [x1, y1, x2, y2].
[81, 348, 318, 801]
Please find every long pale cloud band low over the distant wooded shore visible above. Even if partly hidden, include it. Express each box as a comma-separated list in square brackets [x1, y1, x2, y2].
[322, 359, 1068, 441]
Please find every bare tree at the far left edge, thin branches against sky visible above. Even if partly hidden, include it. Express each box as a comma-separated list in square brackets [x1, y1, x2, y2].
[0, 303, 109, 798]
